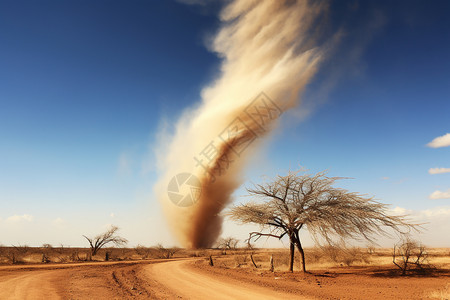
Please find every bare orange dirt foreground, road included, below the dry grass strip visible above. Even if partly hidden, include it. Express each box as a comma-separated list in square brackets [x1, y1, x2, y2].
[0, 259, 450, 299]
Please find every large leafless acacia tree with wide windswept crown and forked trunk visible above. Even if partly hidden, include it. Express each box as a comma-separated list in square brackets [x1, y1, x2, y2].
[228, 171, 415, 272]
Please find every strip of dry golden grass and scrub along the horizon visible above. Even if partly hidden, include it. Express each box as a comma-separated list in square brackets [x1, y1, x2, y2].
[0, 242, 450, 276]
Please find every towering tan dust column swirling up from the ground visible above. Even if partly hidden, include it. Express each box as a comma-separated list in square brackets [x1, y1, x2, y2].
[155, 0, 329, 248]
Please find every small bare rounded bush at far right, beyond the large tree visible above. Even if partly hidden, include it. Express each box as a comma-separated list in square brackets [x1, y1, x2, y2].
[392, 237, 429, 275]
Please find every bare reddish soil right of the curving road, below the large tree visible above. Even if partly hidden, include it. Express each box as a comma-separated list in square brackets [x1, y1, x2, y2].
[193, 262, 450, 300]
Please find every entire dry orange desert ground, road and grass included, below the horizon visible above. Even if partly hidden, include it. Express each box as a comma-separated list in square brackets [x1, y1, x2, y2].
[0, 247, 450, 299]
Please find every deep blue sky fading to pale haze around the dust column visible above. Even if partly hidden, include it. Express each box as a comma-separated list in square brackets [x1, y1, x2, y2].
[0, 0, 450, 246]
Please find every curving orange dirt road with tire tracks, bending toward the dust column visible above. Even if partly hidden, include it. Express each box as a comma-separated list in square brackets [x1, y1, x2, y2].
[0, 259, 305, 299]
